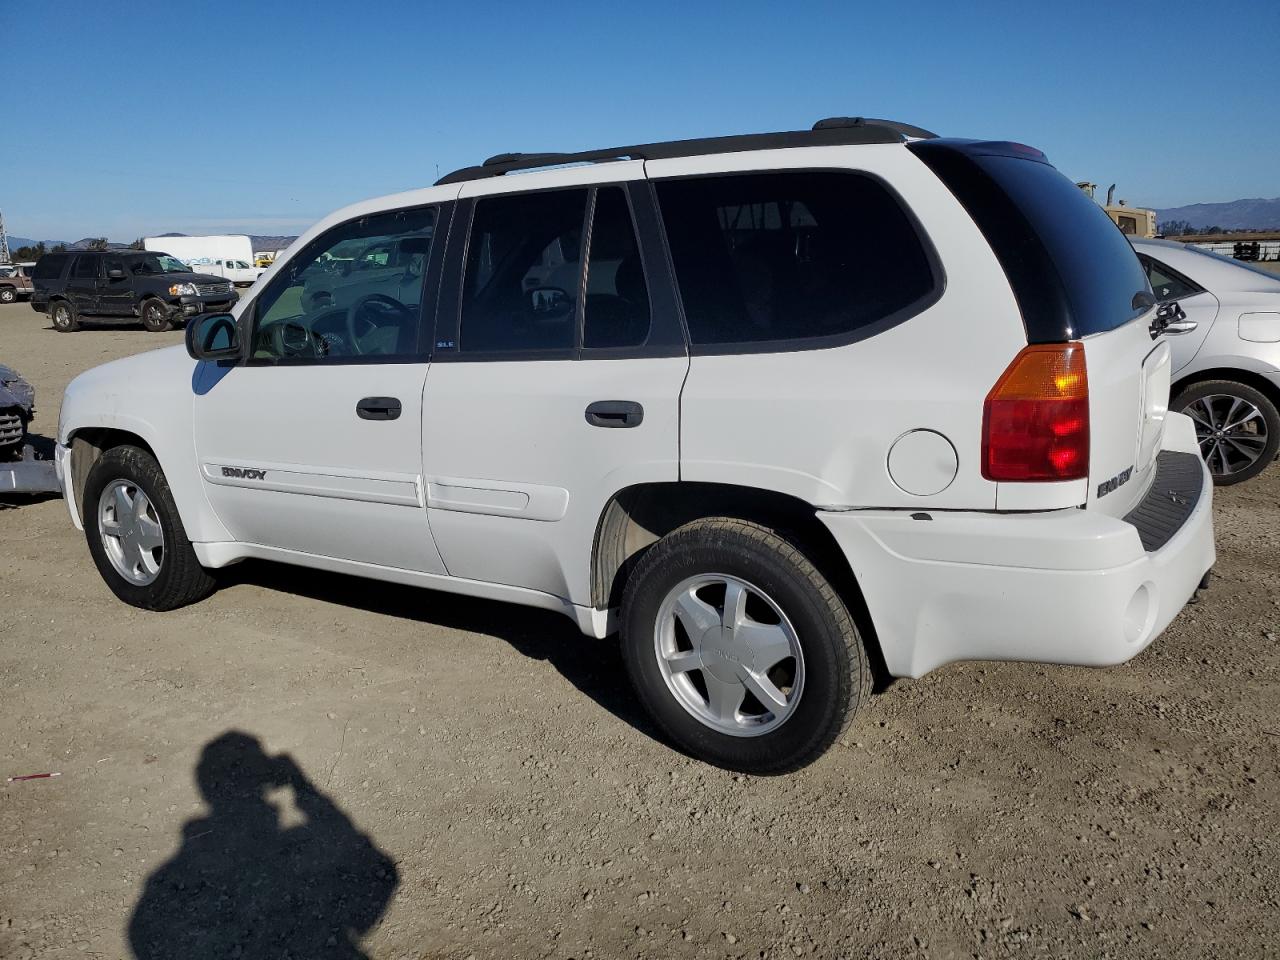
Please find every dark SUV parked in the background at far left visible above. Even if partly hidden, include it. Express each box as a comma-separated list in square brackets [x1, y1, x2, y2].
[31, 250, 239, 333]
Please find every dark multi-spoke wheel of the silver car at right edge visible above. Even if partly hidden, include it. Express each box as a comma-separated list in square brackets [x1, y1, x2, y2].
[1170, 380, 1280, 486]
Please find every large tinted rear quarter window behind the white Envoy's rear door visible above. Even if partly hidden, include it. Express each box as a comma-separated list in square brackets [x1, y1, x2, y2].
[657, 170, 938, 352]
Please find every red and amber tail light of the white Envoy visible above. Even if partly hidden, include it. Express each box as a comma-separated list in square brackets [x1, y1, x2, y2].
[982, 342, 1089, 481]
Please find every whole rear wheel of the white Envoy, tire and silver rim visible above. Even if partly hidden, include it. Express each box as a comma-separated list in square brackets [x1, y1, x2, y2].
[622, 517, 872, 773]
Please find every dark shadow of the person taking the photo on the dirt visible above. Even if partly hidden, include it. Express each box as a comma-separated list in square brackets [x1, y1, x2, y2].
[128, 731, 399, 960]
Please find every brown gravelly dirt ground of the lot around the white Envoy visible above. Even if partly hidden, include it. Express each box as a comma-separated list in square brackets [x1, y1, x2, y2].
[0, 305, 1280, 960]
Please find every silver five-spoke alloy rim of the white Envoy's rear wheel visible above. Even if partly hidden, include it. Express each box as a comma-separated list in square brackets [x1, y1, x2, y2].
[654, 573, 804, 737]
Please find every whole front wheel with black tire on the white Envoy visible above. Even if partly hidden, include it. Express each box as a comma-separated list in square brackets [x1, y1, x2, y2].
[82, 447, 215, 611]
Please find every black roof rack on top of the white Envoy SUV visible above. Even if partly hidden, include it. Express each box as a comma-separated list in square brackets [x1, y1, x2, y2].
[435, 116, 937, 186]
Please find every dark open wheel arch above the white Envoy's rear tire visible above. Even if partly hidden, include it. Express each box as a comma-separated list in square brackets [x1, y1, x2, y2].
[591, 481, 888, 686]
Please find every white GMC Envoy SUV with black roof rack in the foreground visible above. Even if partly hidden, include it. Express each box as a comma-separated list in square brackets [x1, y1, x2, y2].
[58, 119, 1213, 772]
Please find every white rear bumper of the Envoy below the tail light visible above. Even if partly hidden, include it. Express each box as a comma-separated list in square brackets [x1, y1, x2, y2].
[818, 415, 1215, 677]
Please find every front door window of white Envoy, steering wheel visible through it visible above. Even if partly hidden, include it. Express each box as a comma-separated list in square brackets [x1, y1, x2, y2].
[251, 207, 435, 362]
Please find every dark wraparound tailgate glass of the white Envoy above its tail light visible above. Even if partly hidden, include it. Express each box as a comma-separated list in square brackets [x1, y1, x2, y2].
[909, 141, 1149, 343]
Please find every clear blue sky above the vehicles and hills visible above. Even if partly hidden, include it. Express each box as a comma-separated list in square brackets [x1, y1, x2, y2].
[0, 0, 1280, 241]
